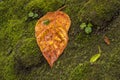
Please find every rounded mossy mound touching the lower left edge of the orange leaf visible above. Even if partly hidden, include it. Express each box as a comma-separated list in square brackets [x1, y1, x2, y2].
[14, 38, 43, 68]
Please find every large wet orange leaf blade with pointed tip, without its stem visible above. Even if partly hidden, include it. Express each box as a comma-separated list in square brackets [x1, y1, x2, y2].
[35, 11, 71, 67]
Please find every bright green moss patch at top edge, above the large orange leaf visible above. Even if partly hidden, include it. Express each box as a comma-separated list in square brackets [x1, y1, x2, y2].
[25, 0, 64, 13]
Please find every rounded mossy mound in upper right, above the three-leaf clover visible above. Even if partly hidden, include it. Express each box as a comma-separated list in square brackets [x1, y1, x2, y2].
[79, 0, 120, 27]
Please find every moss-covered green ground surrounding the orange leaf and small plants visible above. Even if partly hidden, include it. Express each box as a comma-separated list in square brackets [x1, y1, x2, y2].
[0, 0, 120, 80]
